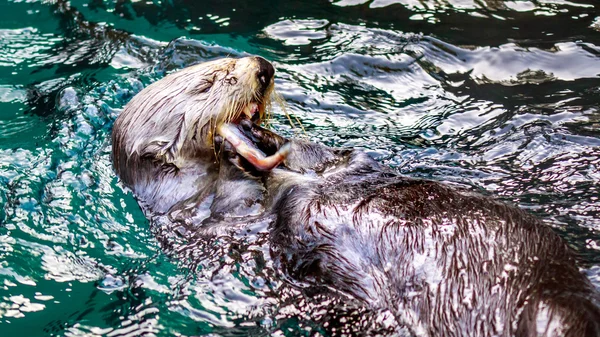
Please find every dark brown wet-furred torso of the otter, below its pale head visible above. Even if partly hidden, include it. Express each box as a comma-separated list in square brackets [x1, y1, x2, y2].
[224, 123, 600, 337]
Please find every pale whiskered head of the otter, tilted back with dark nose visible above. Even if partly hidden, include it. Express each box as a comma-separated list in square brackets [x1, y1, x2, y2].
[112, 57, 275, 186]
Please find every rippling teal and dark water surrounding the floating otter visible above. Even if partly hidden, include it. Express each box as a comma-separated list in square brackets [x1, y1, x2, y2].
[0, 0, 600, 336]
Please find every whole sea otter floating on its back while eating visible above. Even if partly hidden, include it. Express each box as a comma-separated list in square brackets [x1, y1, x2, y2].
[113, 58, 600, 336]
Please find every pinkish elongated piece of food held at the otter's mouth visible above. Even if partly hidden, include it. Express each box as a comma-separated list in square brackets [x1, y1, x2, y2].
[217, 124, 290, 171]
